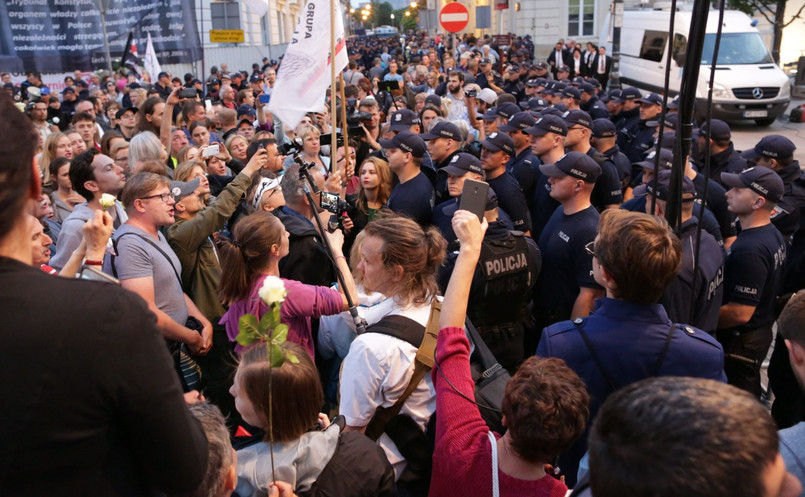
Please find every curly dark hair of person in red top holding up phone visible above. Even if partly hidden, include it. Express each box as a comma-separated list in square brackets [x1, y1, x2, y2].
[501, 357, 590, 463]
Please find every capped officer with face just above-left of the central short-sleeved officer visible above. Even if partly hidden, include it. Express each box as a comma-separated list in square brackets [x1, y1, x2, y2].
[523, 114, 567, 240]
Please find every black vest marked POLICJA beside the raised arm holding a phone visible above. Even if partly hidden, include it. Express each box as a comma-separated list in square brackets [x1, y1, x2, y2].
[467, 231, 533, 332]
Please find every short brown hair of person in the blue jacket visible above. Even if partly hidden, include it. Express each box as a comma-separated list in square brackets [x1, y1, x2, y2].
[595, 209, 682, 304]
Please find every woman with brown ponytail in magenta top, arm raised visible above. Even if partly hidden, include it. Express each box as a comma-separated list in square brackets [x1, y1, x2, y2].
[218, 211, 357, 357]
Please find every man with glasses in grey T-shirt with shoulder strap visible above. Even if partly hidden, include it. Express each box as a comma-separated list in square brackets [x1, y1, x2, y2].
[114, 173, 212, 355]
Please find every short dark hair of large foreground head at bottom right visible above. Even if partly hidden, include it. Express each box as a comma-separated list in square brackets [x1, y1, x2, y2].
[589, 376, 779, 497]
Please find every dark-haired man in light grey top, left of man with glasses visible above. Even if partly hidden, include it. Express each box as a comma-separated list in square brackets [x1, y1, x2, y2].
[50, 148, 127, 270]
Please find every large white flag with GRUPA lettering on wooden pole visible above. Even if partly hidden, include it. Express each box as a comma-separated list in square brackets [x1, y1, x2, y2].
[268, 0, 348, 129]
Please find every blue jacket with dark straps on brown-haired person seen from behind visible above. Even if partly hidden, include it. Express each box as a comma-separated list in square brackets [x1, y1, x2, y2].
[537, 296, 726, 486]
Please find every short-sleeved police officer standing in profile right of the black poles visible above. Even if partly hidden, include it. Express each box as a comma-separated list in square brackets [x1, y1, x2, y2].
[717, 166, 786, 398]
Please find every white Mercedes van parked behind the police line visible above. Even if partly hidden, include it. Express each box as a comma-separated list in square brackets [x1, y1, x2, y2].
[601, 10, 791, 126]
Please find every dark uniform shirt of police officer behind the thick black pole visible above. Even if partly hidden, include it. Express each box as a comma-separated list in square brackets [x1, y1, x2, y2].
[660, 217, 725, 335]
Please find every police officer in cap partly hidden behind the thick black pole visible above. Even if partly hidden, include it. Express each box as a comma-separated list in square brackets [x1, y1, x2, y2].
[635, 170, 724, 335]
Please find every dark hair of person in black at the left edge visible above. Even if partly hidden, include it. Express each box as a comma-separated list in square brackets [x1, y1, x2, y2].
[0, 92, 39, 239]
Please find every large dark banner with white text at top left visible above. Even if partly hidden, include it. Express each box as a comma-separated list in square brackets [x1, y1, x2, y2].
[0, 0, 202, 73]
